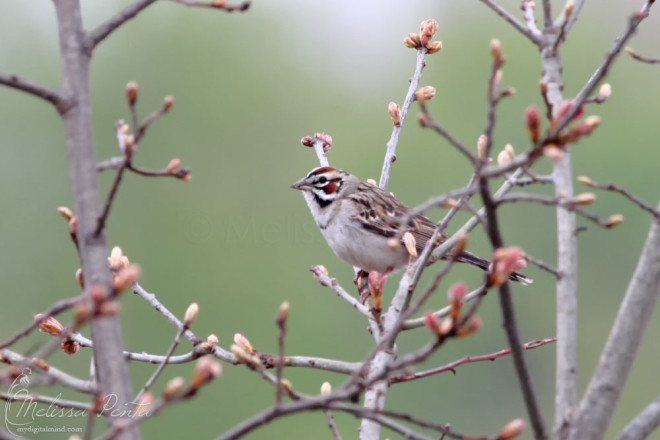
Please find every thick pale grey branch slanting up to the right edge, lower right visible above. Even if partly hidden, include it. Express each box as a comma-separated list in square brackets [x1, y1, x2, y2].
[568, 209, 660, 440]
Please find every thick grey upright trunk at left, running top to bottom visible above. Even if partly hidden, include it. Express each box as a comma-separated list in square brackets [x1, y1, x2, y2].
[54, 0, 140, 440]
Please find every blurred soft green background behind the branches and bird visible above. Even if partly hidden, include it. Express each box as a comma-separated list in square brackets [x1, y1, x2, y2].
[0, 0, 660, 439]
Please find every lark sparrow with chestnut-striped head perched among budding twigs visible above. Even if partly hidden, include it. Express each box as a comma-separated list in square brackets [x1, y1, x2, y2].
[291, 167, 532, 283]
